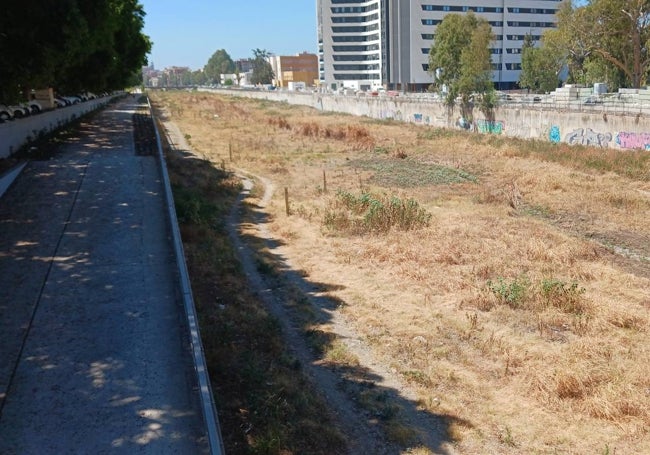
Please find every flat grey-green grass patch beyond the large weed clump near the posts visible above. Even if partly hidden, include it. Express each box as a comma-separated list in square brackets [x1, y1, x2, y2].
[349, 159, 478, 188]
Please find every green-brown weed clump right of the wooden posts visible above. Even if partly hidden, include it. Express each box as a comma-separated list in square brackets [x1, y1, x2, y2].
[323, 191, 431, 234]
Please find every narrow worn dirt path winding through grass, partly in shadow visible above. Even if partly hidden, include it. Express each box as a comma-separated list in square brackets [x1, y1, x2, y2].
[227, 170, 453, 454]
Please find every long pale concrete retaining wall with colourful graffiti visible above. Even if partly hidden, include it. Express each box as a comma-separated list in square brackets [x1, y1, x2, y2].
[202, 89, 650, 150]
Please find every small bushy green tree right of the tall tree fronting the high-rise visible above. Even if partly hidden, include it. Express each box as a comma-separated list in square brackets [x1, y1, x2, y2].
[519, 35, 564, 93]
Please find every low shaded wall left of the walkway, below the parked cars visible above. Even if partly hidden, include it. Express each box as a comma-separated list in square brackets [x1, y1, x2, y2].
[0, 96, 115, 158]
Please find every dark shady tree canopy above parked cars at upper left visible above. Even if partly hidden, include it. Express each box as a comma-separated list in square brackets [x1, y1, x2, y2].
[0, 0, 151, 102]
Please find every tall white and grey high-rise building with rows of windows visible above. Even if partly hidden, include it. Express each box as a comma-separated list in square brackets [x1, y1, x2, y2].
[316, 0, 560, 91]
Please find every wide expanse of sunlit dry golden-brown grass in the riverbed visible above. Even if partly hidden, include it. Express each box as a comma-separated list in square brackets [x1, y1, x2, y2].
[152, 92, 650, 454]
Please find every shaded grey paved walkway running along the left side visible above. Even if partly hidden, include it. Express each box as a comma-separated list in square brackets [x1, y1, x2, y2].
[0, 99, 208, 455]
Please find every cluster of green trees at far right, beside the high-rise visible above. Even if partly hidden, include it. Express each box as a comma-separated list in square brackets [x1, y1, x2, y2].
[520, 0, 650, 91]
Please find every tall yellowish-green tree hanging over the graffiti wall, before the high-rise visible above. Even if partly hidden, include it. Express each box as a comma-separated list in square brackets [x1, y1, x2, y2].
[429, 11, 496, 118]
